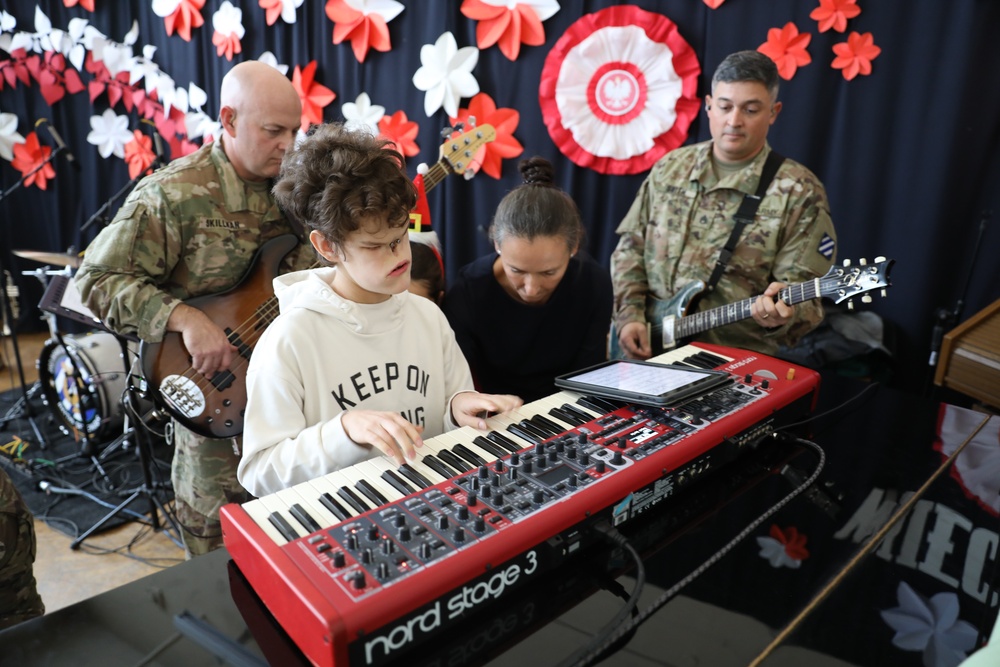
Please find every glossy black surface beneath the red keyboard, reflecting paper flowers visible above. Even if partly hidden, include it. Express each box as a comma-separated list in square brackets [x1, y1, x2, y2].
[0, 376, 1000, 667]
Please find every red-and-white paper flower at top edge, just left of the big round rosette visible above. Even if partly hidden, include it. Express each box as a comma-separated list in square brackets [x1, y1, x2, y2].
[462, 0, 559, 60]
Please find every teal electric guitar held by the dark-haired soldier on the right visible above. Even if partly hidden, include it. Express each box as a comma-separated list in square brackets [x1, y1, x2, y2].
[608, 257, 894, 359]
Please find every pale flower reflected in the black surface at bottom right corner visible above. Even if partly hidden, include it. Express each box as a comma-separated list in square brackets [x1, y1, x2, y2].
[881, 581, 977, 667]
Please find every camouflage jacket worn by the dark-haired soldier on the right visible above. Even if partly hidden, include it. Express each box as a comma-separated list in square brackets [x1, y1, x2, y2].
[611, 141, 836, 354]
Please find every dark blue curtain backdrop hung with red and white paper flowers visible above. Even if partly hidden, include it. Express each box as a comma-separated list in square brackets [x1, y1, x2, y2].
[0, 0, 1000, 390]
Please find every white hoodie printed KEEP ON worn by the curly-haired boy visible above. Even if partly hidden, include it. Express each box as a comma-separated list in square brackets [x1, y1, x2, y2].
[237, 268, 473, 497]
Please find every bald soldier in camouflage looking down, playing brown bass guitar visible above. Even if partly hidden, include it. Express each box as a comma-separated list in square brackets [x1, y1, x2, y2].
[76, 61, 316, 557]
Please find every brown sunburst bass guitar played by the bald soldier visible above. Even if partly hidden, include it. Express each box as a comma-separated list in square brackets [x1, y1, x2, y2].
[139, 125, 496, 438]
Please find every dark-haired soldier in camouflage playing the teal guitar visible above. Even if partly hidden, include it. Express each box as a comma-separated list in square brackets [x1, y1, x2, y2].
[611, 51, 836, 359]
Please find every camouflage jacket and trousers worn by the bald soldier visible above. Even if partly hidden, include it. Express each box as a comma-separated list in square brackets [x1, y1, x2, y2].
[76, 142, 316, 555]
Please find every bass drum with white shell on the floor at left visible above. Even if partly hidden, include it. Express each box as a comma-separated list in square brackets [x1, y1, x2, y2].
[38, 332, 127, 440]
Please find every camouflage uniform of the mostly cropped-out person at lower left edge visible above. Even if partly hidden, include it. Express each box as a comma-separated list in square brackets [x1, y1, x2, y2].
[0, 468, 45, 629]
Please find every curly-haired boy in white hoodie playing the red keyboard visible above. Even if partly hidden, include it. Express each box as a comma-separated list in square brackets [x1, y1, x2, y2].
[238, 125, 522, 496]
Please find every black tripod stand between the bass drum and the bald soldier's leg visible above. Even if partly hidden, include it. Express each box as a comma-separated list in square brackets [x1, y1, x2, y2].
[69, 334, 180, 549]
